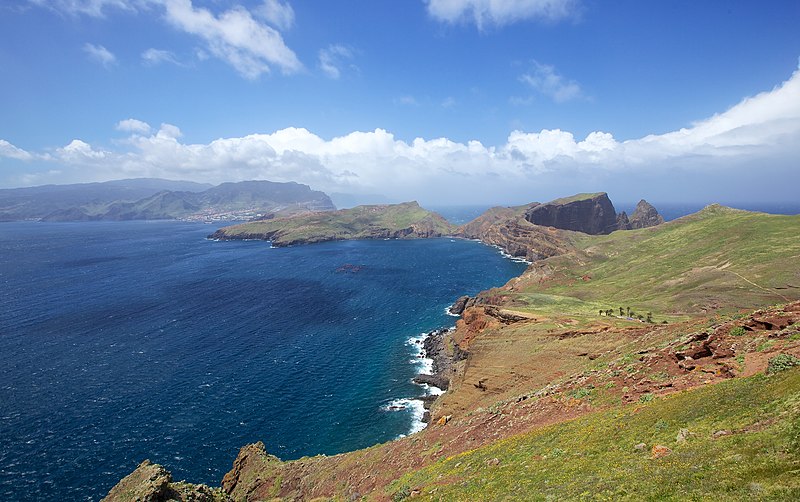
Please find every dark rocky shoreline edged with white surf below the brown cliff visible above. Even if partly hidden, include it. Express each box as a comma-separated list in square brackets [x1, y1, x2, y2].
[413, 327, 468, 424]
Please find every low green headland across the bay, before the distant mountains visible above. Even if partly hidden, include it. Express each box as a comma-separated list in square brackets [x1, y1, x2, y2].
[211, 202, 455, 246]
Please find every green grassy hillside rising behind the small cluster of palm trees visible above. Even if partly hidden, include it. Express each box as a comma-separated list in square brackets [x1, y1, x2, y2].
[506, 206, 800, 318]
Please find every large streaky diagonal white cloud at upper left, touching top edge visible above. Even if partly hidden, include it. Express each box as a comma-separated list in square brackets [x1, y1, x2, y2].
[161, 0, 302, 79]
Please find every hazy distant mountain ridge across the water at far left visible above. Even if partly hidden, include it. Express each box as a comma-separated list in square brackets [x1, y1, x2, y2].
[0, 178, 335, 221]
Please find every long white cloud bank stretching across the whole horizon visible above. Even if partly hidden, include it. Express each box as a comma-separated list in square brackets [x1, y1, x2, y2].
[0, 65, 800, 204]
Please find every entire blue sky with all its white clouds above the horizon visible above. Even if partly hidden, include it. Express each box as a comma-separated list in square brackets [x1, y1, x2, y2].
[0, 0, 800, 204]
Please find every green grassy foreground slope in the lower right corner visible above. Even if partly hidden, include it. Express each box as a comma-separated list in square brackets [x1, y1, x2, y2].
[386, 368, 800, 500]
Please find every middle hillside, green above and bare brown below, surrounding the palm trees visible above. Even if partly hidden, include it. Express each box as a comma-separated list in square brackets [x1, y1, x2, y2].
[439, 207, 800, 415]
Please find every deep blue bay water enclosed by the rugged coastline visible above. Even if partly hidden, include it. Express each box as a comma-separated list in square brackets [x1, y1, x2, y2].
[0, 222, 524, 500]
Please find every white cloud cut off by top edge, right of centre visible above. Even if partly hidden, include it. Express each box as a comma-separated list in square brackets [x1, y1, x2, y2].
[427, 0, 577, 30]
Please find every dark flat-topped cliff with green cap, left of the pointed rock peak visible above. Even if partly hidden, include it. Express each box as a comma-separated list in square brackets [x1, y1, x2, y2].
[525, 192, 617, 235]
